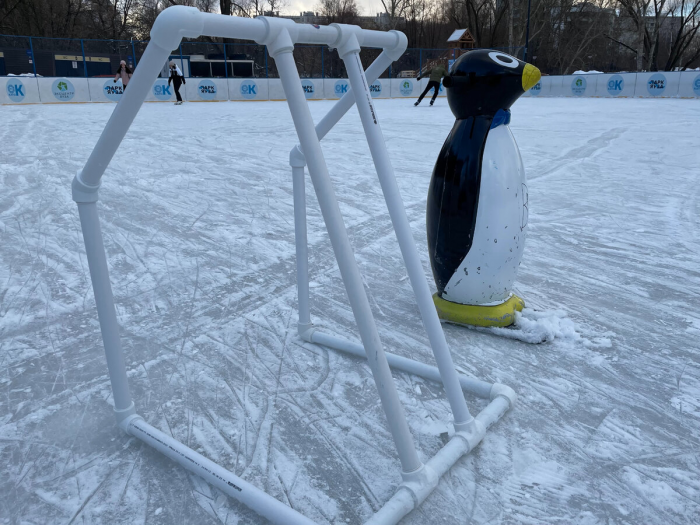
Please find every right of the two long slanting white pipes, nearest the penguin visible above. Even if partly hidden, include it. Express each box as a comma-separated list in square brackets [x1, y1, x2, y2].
[341, 49, 473, 428]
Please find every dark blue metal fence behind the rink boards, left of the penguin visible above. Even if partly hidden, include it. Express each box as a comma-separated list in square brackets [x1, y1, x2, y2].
[0, 35, 522, 78]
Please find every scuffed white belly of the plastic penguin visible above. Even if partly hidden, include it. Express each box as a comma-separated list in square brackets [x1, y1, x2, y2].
[443, 125, 528, 305]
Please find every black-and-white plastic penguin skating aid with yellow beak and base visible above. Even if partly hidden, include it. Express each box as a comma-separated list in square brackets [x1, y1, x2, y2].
[426, 50, 540, 326]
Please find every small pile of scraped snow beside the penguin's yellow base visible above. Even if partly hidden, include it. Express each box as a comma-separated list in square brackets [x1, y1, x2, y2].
[487, 308, 612, 347]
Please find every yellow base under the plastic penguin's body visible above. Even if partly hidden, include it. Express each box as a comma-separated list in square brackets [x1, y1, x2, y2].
[433, 294, 525, 326]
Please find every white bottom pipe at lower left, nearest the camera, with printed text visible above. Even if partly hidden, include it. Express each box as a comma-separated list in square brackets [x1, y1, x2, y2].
[126, 416, 316, 525]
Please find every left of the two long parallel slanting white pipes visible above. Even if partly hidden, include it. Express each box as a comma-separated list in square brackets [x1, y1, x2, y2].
[274, 45, 422, 473]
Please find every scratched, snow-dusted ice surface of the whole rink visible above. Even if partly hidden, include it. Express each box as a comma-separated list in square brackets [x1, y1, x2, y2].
[0, 99, 700, 525]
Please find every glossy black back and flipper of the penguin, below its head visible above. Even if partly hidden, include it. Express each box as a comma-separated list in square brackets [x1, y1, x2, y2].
[426, 116, 492, 296]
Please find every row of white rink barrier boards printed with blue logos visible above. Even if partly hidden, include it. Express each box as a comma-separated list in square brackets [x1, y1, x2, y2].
[0, 71, 700, 105]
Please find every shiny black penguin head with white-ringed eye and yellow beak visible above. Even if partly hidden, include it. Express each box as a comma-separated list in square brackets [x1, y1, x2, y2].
[443, 49, 540, 119]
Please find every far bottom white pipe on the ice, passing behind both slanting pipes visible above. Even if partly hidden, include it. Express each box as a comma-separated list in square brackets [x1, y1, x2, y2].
[302, 330, 493, 399]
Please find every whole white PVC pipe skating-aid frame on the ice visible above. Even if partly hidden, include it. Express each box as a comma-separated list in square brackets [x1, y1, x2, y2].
[72, 6, 516, 525]
